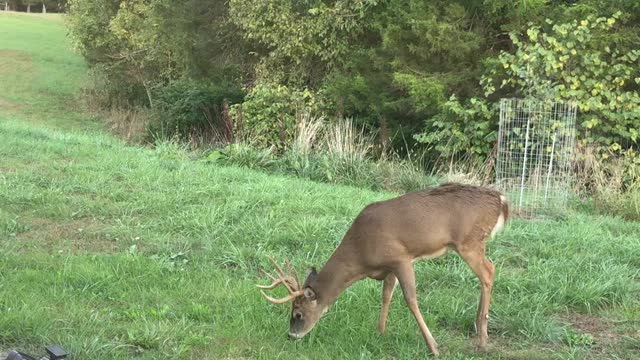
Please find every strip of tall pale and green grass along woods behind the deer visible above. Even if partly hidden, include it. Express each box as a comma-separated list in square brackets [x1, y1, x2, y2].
[210, 114, 438, 192]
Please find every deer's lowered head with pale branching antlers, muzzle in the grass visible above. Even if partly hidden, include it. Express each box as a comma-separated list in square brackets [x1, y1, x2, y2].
[258, 259, 327, 339]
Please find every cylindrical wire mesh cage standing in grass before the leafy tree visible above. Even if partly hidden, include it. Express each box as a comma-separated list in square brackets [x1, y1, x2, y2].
[496, 99, 576, 216]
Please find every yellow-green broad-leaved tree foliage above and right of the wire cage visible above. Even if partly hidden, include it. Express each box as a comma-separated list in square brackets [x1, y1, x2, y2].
[485, 12, 640, 152]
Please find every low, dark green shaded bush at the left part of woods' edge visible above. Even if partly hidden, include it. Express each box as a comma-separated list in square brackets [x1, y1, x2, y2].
[150, 80, 243, 142]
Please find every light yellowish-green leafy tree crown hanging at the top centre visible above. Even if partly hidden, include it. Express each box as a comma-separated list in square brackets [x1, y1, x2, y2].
[229, 0, 378, 86]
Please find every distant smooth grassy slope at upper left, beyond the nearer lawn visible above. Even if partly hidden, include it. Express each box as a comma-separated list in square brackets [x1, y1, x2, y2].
[0, 11, 101, 130]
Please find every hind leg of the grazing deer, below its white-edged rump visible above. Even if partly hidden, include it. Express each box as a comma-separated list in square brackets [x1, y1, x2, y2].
[456, 243, 495, 349]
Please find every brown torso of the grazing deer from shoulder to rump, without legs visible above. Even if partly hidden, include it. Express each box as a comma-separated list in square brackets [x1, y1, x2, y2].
[345, 184, 506, 265]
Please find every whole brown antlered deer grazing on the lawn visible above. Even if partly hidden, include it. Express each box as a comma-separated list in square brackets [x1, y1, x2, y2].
[258, 183, 509, 355]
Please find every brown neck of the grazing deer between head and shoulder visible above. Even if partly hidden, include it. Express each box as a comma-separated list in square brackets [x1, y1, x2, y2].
[314, 245, 364, 307]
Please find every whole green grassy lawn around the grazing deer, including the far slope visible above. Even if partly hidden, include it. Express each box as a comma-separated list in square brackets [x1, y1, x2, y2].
[0, 13, 640, 359]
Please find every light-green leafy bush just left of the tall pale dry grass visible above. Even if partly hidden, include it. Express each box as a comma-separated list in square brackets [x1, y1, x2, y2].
[231, 83, 319, 150]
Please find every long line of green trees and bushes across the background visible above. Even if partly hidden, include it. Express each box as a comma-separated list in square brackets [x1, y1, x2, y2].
[67, 0, 640, 166]
